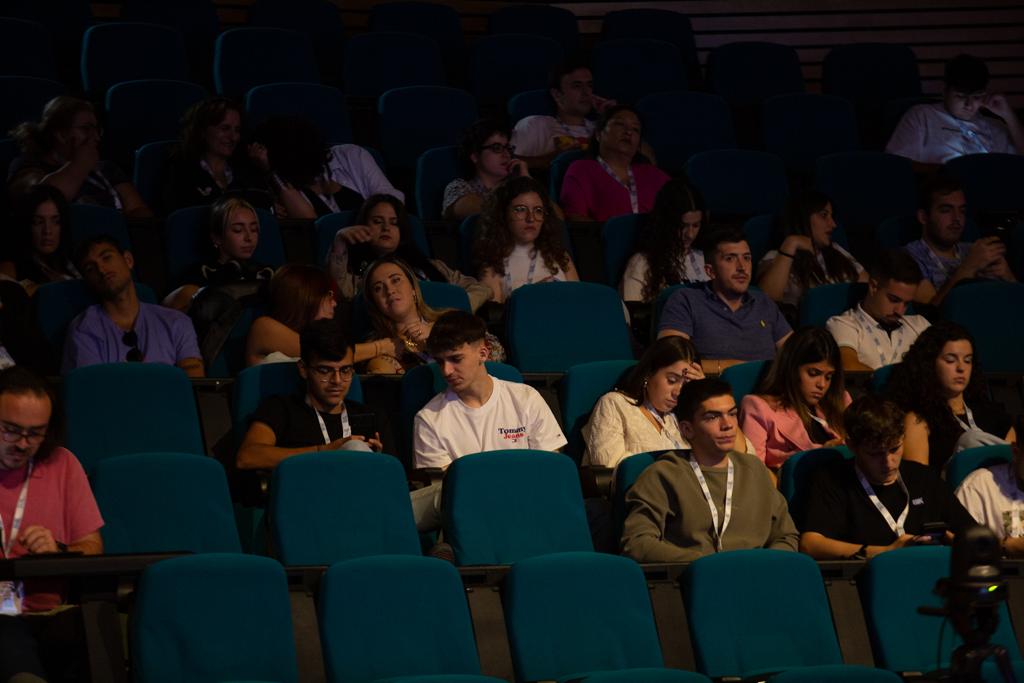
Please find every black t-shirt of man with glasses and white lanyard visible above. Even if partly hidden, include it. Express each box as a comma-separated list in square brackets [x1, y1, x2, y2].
[252, 394, 380, 449]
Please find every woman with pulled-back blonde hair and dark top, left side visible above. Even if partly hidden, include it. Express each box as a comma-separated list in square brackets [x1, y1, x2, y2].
[164, 196, 273, 311]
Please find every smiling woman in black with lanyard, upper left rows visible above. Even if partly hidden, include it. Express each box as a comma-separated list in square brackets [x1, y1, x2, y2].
[164, 97, 269, 212]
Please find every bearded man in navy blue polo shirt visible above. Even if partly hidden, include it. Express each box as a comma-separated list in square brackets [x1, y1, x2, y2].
[657, 228, 793, 374]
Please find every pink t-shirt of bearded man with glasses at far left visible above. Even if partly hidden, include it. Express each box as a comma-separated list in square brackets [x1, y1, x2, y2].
[0, 447, 103, 611]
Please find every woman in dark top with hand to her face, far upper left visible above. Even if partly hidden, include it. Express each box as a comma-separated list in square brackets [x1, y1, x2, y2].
[8, 95, 153, 218]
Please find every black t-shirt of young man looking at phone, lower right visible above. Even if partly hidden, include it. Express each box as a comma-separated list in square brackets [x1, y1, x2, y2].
[801, 460, 976, 546]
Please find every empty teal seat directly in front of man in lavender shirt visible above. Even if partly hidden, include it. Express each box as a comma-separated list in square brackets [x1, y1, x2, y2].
[61, 362, 206, 472]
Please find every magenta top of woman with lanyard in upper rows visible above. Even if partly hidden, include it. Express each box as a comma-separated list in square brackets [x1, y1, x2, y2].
[560, 159, 670, 221]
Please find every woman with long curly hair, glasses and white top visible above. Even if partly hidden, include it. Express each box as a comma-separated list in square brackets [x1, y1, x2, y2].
[474, 177, 580, 303]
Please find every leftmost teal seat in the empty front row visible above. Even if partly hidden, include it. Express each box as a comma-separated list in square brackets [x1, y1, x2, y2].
[130, 553, 298, 683]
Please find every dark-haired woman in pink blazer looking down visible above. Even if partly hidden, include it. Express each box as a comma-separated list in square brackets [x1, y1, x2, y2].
[739, 328, 850, 471]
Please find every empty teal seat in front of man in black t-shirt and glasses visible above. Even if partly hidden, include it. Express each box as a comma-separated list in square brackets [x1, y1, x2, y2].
[267, 451, 420, 566]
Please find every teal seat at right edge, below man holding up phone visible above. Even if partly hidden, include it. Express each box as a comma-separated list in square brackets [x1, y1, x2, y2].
[940, 281, 1024, 373]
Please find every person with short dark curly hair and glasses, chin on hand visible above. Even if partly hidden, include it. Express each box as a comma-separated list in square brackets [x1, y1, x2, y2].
[441, 119, 529, 220]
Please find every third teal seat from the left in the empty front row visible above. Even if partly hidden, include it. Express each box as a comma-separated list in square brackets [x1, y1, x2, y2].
[504, 552, 708, 683]
